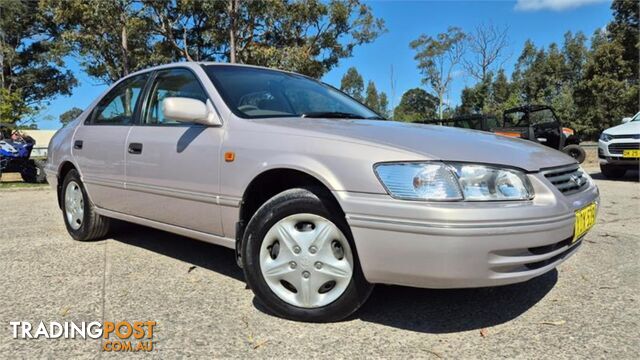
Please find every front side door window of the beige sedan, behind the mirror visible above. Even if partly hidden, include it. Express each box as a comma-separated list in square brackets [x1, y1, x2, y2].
[144, 69, 207, 125]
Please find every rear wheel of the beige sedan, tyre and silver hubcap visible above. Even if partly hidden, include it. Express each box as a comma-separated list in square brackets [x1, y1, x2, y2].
[61, 170, 110, 241]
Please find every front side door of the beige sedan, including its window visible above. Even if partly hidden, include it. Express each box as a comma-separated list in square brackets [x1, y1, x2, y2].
[126, 68, 223, 235]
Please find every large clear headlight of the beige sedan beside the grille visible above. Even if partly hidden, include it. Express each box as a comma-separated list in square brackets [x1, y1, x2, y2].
[374, 162, 533, 201]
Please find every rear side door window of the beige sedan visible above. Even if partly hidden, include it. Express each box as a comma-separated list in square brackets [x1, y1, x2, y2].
[91, 74, 148, 125]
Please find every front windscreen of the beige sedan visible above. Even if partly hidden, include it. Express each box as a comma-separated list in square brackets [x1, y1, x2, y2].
[204, 65, 381, 119]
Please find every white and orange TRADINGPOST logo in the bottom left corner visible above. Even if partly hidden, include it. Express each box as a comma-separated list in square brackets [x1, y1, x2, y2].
[9, 321, 157, 352]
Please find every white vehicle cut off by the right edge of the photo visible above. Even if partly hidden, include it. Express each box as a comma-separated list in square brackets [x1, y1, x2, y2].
[598, 112, 640, 179]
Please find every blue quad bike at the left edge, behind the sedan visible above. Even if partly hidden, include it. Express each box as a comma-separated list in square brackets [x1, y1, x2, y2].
[0, 124, 47, 183]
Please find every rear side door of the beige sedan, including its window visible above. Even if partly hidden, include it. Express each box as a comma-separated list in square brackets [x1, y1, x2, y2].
[71, 74, 149, 211]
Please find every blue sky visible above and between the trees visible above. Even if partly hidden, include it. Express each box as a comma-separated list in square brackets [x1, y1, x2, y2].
[38, 0, 612, 129]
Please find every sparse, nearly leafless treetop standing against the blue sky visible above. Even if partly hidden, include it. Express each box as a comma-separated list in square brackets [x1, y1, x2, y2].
[463, 24, 509, 81]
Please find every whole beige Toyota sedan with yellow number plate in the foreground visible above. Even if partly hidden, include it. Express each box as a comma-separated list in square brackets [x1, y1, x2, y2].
[46, 62, 599, 321]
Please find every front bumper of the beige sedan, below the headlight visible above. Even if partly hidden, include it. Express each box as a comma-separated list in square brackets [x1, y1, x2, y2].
[335, 174, 599, 288]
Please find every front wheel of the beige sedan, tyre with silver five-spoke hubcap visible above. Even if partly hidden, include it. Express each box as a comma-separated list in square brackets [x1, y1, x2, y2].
[242, 188, 373, 322]
